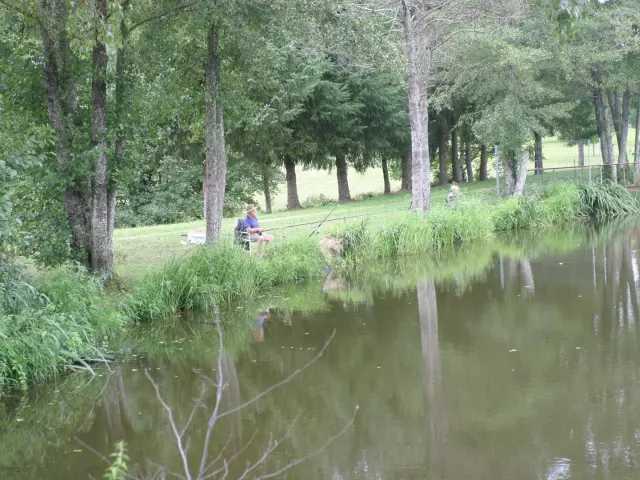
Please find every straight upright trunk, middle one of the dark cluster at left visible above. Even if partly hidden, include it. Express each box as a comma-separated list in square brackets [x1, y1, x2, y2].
[91, 0, 113, 276]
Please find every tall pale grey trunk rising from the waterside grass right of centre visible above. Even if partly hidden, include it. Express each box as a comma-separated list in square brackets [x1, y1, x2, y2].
[401, 0, 432, 213]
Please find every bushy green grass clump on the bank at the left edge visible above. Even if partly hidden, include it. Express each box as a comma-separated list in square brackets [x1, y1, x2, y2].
[0, 266, 124, 391]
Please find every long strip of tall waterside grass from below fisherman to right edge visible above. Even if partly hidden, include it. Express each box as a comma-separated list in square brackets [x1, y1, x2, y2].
[124, 182, 638, 321]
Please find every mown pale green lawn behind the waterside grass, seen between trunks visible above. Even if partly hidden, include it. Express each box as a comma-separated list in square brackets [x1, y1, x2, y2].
[115, 131, 635, 280]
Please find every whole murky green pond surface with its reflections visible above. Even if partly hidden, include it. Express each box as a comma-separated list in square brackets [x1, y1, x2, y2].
[0, 223, 640, 480]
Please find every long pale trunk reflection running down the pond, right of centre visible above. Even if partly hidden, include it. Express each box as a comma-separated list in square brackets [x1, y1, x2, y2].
[417, 280, 446, 478]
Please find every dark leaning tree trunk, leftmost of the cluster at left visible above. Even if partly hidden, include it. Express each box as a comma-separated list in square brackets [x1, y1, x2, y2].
[40, 0, 91, 268]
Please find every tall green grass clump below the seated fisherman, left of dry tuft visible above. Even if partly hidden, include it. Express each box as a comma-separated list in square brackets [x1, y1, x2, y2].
[122, 240, 322, 322]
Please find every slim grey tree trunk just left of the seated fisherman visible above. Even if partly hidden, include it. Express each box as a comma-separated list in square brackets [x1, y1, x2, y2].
[204, 21, 227, 244]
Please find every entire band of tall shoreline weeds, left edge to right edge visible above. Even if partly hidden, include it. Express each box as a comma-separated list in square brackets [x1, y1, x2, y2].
[0, 182, 640, 394]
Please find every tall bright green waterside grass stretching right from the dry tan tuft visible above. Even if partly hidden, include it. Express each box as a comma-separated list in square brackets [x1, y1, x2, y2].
[333, 182, 639, 262]
